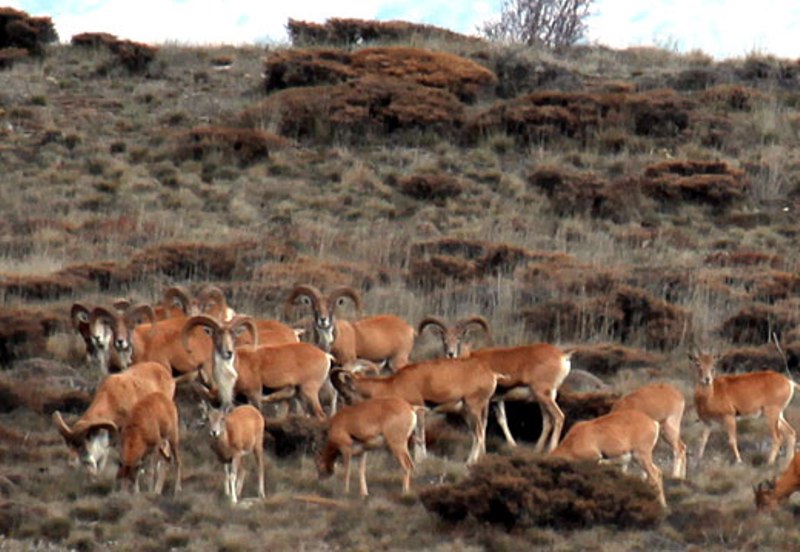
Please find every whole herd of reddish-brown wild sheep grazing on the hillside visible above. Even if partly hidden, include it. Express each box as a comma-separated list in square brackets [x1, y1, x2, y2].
[53, 285, 800, 509]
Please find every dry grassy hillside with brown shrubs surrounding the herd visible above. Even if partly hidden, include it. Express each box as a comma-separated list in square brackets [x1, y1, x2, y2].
[0, 10, 800, 550]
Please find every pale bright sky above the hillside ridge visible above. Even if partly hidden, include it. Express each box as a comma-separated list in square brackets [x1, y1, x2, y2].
[9, 0, 800, 59]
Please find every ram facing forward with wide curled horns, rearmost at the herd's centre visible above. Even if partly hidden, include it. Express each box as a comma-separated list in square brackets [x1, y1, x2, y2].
[286, 285, 415, 371]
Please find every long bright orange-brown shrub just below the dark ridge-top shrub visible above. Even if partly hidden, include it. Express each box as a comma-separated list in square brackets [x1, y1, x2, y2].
[264, 46, 497, 100]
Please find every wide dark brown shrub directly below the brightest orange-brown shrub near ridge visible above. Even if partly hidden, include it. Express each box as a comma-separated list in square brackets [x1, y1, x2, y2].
[247, 76, 464, 141]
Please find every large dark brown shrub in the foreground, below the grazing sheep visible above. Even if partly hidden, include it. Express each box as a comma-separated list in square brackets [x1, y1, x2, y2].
[419, 451, 663, 530]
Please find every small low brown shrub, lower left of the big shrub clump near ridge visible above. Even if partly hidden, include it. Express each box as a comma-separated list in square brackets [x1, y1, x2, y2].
[176, 126, 287, 166]
